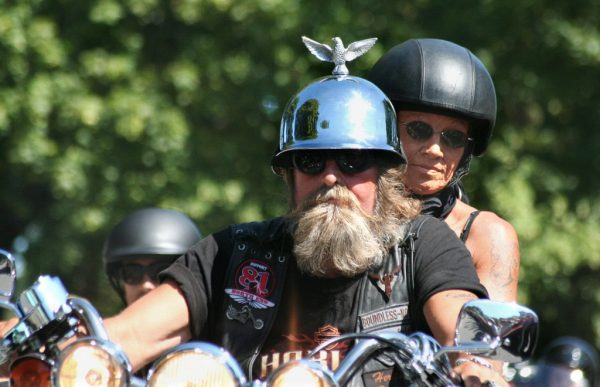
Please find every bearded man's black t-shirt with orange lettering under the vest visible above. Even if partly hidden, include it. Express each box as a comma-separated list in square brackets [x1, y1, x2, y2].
[161, 218, 487, 377]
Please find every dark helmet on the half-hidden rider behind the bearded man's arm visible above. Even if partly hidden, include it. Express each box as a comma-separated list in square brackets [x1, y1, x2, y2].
[102, 208, 202, 304]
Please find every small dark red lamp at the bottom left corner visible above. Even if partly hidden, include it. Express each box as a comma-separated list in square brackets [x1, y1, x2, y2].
[10, 353, 52, 387]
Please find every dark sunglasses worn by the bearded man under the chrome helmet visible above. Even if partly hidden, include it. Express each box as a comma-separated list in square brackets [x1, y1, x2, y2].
[292, 149, 375, 175]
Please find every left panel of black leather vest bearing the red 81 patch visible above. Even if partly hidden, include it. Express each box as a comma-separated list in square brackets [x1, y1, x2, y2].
[214, 218, 291, 378]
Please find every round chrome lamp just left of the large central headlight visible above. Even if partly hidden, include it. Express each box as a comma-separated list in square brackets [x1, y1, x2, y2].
[52, 337, 131, 387]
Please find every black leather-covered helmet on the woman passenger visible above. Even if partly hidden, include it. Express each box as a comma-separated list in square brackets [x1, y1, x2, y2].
[368, 39, 496, 181]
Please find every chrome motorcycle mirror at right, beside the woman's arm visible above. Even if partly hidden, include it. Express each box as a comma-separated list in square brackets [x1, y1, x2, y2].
[455, 300, 539, 363]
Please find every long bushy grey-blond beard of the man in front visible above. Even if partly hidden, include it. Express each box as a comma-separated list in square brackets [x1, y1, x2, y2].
[289, 185, 404, 277]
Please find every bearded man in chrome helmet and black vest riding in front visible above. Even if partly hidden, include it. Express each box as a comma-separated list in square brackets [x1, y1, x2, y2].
[105, 41, 506, 385]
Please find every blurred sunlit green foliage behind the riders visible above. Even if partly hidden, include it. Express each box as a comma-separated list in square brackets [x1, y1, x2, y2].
[0, 0, 600, 358]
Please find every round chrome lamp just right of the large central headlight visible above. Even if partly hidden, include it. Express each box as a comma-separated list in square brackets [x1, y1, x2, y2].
[266, 359, 338, 387]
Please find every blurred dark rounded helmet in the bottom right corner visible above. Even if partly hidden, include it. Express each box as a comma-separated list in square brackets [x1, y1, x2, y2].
[536, 337, 600, 387]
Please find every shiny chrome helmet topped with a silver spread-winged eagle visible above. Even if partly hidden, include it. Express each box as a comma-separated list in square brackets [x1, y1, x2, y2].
[271, 38, 404, 172]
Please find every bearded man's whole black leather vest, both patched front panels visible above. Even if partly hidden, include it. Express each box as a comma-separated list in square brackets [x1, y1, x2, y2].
[214, 216, 427, 384]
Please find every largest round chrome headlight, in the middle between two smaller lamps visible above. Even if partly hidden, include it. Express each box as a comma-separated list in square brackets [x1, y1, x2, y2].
[148, 342, 246, 387]
